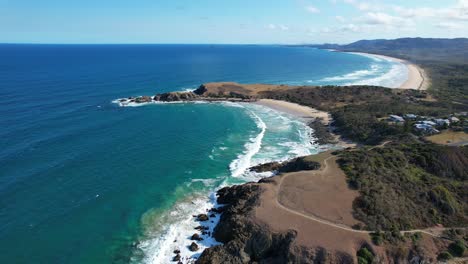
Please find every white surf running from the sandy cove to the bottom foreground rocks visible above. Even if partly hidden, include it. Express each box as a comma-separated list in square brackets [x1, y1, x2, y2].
[139, 102, 319, 264]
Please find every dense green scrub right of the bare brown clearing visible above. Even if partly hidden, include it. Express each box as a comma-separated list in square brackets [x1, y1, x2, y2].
[339, 139, 468, 233]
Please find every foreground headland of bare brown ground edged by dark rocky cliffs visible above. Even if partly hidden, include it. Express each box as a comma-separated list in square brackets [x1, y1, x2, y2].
[196, 148, 466, 264]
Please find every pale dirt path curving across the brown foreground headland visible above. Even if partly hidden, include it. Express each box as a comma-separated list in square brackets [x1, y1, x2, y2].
[275, 154, 468, 237]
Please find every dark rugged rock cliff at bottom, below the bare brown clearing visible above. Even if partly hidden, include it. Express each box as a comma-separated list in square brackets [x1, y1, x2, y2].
[196, 183, 332, 264]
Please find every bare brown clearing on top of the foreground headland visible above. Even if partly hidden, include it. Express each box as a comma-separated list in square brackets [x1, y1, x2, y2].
[255, 152, 371, 261]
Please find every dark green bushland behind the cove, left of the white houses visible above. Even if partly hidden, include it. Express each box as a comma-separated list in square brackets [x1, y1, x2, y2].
[261, 86, 451, 144]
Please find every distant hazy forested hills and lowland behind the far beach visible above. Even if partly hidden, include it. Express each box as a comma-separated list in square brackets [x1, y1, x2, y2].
[316, 38, 468, 107]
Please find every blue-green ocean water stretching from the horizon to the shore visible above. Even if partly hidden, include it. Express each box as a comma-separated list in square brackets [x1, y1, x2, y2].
[0, 45, 407, 263]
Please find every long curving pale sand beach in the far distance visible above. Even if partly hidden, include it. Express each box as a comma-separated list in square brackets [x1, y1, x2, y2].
[352, 52, 431, 90]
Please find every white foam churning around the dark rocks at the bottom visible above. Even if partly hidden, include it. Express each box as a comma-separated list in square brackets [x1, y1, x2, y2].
[138, 193, 220, 264]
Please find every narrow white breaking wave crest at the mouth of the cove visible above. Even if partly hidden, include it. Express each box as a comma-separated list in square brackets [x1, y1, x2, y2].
[229, 111, 266, 177]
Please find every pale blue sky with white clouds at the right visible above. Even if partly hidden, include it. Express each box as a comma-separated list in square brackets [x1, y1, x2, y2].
[0, 0, 468, 44]
